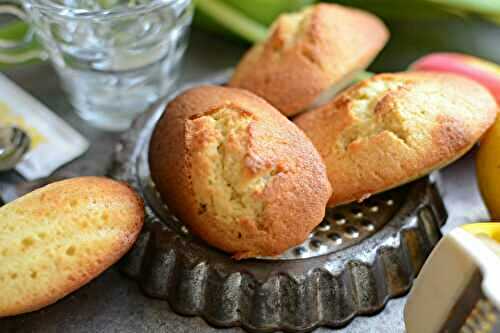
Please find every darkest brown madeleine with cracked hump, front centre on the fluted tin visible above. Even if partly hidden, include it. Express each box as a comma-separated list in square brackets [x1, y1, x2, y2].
[149, 86, 331, 259]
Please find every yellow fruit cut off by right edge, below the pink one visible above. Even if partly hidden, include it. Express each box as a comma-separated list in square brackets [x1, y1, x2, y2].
[477, 117, 500, 219]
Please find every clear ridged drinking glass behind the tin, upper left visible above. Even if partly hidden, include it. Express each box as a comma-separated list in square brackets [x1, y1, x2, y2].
[0, 0, 193, 130]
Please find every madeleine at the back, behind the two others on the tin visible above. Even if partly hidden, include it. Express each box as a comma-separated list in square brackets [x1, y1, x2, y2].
[229, 4, 389, 117]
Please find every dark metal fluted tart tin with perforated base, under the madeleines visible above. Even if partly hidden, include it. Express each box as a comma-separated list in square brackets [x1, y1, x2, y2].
[110, 72, 447, 332]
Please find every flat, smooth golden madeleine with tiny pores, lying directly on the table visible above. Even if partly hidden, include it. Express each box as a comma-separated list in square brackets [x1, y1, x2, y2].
[0, 177, 144, 317]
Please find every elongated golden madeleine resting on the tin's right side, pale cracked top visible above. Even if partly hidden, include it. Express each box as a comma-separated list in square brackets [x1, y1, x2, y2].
[295, 72, 497, 206]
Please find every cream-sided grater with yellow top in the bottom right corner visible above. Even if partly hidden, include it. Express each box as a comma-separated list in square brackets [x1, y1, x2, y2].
[405, 223, 500, 333]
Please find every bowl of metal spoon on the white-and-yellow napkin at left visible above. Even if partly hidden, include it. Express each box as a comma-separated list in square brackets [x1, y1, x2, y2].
[0, 127, 31, 171]
